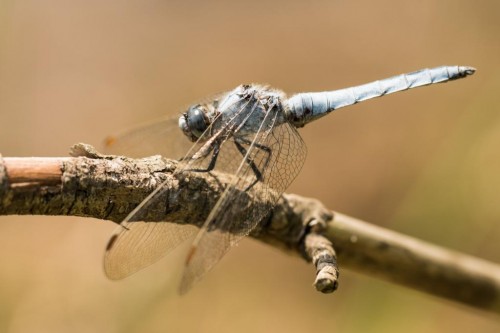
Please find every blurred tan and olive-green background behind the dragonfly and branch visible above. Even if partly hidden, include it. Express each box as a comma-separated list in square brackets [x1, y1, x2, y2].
[0, 0, 500, 332]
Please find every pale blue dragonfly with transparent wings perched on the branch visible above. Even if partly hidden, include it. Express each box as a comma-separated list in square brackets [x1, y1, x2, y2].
[104, 66, 475, 293]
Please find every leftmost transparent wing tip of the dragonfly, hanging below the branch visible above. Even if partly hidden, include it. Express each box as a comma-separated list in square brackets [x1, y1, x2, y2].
[104, 222, 197, 280]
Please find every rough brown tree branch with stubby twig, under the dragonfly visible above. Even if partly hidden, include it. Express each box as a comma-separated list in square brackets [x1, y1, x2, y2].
[0, 145, 500, 314]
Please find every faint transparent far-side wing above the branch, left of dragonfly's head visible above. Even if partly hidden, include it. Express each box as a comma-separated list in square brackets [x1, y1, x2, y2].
[104, 117, 193, 159]
